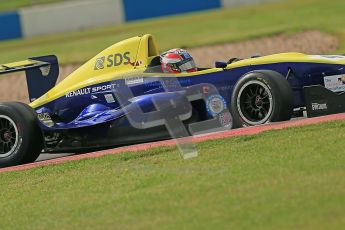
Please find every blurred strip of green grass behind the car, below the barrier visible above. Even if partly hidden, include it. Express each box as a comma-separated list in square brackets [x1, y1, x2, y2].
[0, 0, 345, 63]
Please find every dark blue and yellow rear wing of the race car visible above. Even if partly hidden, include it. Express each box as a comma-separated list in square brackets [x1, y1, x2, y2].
[0, 55, 59, 102]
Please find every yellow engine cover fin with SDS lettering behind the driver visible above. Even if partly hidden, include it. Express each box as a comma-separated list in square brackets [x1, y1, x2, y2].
[30, 35, 158, 108]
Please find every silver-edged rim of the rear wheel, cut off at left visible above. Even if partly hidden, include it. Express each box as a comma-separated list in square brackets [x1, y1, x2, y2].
[0, 115, 18, 158]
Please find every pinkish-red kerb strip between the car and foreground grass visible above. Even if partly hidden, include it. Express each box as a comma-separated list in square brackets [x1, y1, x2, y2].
[0, 113, 345, 173]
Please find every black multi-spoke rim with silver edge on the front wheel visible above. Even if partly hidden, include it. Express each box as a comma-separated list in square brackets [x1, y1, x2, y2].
[237, 80, 273, 125]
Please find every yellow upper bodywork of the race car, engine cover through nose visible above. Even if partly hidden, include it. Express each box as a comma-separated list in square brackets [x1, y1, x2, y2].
[28, 34, 345, 108]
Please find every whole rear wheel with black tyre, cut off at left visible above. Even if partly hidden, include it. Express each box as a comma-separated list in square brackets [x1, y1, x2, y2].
[0, 102, 43, 167]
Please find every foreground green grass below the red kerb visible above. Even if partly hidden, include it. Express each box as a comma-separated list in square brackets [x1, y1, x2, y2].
[0, 121, 345, 230]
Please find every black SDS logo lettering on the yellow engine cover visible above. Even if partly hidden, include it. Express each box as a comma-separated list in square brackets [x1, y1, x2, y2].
[94, 52, 131, 70]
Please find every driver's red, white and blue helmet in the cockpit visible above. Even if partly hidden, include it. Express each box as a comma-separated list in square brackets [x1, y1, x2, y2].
[160, 49, 197, 73]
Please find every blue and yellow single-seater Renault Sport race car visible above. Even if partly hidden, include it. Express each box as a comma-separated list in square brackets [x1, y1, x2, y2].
[0, 34, 345, 167]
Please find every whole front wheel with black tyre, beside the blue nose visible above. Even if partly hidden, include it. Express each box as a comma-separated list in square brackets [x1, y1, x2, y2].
[231, 70, 294, 128]
